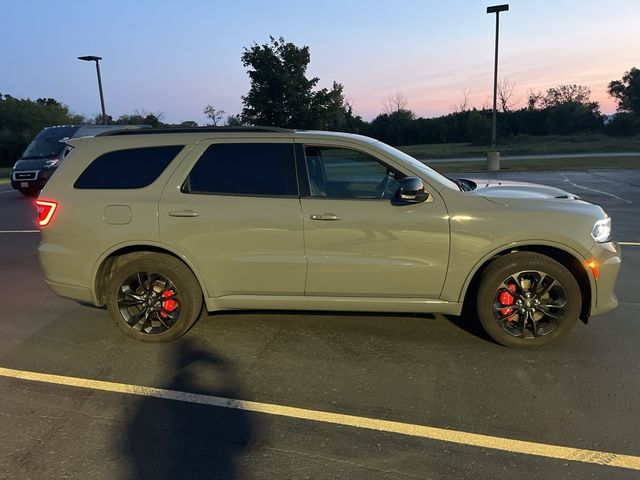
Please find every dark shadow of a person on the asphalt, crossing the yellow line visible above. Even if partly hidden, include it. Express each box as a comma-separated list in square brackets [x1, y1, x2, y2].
[120, 337, 251, 480]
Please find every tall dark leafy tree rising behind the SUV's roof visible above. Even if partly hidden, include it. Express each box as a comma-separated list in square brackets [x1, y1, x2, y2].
[241, 37, 345, 129]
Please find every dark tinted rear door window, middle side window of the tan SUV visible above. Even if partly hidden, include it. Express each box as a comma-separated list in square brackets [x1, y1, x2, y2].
[183, 143, 298, 196]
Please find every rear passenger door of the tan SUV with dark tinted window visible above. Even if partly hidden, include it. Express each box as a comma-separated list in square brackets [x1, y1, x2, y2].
[159, 138, 306, 297]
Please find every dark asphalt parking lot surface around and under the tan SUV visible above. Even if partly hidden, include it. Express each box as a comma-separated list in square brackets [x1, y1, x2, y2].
[0, 170, 640, 479]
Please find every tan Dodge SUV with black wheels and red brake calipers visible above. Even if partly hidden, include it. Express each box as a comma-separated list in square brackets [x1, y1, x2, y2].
[37, 128, 620, 347]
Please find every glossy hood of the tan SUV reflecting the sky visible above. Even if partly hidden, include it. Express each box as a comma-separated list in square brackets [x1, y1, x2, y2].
[467, 178, 580, 203]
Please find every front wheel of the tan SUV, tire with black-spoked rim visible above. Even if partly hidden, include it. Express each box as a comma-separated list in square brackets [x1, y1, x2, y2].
[476, 252, 582, 348]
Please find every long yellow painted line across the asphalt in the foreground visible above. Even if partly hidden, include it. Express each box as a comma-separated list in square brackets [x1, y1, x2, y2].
[0, 367, 640, 471]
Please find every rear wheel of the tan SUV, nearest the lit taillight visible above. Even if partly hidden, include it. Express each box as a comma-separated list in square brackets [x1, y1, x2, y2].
[107, 252, 202, 343]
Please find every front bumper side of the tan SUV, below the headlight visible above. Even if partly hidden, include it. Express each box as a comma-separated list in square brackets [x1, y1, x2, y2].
[589, 242, 622, 316]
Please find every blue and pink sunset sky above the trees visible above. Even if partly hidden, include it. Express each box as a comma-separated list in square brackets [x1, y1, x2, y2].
[0, 0, 640, 124]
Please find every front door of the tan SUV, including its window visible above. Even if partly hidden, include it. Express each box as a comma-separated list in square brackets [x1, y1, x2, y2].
[301, 145, 449, 298]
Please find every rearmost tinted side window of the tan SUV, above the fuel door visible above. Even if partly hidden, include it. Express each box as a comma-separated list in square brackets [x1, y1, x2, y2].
[73, 145, 184, 189]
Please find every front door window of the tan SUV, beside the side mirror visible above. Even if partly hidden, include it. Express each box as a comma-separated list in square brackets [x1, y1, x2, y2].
[304, 145, 405, 199]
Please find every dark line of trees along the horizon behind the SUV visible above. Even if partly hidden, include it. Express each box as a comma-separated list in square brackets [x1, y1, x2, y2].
[0, 37, 640, 165]
